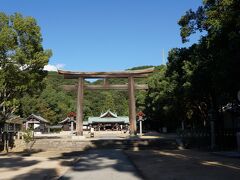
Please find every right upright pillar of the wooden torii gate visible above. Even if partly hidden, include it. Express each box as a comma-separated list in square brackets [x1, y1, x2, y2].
[128, 76, 137, 134]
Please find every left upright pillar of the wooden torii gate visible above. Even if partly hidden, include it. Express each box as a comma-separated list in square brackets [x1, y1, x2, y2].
[76, 77, 84, 136]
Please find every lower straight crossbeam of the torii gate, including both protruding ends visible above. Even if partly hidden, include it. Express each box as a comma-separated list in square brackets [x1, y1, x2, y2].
[62, 84, 148, 91]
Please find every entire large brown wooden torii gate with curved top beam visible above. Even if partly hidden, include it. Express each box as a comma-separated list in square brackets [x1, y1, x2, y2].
[58, 68, 154, 136]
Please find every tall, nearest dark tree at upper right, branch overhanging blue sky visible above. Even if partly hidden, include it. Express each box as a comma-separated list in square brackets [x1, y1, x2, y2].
[179, 0, 240, 104]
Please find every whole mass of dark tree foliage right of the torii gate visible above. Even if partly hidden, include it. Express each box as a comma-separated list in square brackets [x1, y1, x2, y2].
[143, 0, 240, 131]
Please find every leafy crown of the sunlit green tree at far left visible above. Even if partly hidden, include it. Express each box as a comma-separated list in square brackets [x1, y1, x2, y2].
[0, 13, 51, 122]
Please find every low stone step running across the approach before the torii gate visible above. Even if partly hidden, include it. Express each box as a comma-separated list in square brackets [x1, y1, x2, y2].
[29, 139, 177, 151]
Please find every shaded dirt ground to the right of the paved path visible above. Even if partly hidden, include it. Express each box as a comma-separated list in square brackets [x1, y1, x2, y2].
[125, 150, 240, 180]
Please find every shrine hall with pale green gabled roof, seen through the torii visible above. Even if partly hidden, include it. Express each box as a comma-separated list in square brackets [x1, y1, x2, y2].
[88, 110, 129, 131]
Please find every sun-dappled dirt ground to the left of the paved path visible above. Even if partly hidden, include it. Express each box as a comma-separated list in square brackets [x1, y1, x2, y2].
[0, 151, 76, 180]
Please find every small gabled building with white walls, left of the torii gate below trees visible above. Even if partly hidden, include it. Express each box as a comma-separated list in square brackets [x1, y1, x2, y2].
[25, 114, 50, 133]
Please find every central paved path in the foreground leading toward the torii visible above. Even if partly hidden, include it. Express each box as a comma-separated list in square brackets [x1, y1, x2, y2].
[60, 149, 141, 180]
